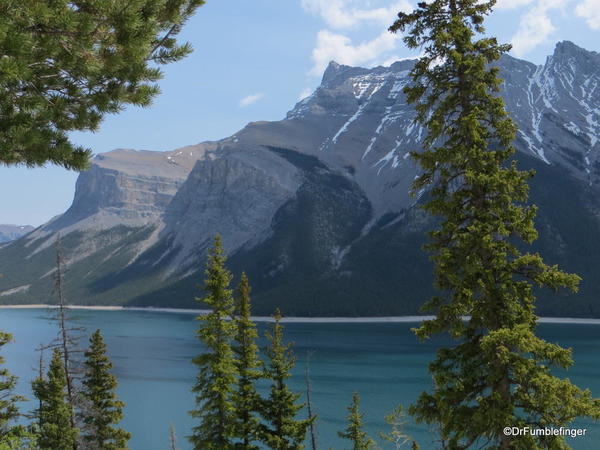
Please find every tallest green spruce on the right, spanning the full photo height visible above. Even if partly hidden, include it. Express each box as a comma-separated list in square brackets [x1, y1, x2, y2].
[390, 0, 600, 449]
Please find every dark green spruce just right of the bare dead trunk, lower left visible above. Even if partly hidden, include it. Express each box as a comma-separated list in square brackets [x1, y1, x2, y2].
[81, 330, 131, 450]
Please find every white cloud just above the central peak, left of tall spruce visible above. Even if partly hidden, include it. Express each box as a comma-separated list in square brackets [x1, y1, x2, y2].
[310, 30, 400, 76]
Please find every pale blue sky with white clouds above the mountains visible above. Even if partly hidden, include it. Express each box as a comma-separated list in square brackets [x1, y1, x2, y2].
[0, 0, 600, 225]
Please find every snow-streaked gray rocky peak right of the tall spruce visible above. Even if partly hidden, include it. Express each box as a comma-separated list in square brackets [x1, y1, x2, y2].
[501, 42, 600, 178]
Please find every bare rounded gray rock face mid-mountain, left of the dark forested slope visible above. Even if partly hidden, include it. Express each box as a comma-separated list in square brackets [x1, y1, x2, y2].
[162, 146, 301, 274]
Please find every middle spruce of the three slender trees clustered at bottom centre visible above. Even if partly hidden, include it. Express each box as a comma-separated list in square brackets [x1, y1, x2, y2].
[233, 273, 262, 449]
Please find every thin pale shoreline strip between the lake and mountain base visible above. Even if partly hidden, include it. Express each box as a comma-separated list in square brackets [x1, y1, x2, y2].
[0, 303, 600, 325]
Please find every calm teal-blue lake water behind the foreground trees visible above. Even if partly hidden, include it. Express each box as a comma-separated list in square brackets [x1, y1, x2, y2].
[0, 309, 600, 450]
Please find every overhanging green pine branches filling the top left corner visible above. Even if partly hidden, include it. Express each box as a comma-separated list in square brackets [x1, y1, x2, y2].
[0, 0, 204, 170]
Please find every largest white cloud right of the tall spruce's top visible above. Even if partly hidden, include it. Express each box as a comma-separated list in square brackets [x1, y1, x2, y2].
[508, 0, 568, 56]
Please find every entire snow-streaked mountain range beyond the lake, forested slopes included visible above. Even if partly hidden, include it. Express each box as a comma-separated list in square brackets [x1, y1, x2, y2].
[0, 42, 600, 317]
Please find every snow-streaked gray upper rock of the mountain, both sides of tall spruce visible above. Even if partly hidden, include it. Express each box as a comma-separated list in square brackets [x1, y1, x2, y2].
[226, 42, 600, 224]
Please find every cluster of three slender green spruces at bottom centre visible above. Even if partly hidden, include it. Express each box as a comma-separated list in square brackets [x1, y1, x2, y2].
[189, 244, 313, 450]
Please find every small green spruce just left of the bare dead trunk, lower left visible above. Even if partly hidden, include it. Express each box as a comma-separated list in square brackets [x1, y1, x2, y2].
[32, 348, 79, 450]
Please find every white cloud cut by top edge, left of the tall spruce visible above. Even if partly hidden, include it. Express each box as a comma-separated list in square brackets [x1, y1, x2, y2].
[301, 0, 412, 29]
